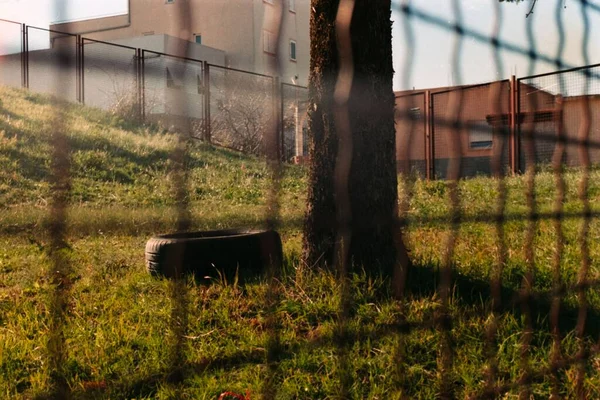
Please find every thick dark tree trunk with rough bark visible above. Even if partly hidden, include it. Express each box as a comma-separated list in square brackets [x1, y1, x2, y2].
[304, 0, 408, 276]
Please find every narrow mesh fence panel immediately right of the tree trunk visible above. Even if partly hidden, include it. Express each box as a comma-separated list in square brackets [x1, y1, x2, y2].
[396, 92, 429, 178]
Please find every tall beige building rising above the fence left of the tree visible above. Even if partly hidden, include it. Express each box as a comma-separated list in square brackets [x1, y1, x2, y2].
[51, 0, 310, 85]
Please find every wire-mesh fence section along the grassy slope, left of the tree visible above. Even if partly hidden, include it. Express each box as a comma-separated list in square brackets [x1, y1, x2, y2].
[0, 20, 307, 161]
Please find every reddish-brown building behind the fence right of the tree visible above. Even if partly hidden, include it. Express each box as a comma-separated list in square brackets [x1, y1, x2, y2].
[395, 80, 600, 178]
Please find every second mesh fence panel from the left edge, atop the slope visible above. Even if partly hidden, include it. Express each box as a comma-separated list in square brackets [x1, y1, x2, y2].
[27, 26, 78, 101]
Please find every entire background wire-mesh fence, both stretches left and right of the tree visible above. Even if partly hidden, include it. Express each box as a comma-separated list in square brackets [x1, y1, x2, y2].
[5, 18, 600, 175]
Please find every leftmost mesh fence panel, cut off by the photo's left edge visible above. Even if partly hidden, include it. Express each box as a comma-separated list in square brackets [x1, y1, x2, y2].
[0, 20, 23, 87]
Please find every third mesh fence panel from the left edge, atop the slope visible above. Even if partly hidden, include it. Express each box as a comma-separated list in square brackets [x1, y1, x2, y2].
[82, 39, 139, 117]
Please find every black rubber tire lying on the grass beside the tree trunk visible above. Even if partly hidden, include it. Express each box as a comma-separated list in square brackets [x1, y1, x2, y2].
[145, 229, 283, 283]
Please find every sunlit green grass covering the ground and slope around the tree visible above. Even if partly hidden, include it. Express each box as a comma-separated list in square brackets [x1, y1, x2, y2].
[0, 84, 600, 399]
